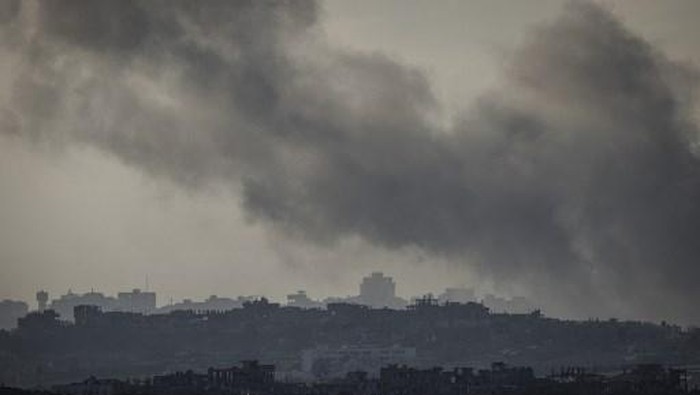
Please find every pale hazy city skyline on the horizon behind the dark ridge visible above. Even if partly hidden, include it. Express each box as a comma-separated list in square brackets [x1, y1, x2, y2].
[0, 272, 541, 329]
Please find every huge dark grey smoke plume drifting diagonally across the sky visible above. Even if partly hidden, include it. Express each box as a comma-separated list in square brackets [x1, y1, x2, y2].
[0, 0, 700, 322]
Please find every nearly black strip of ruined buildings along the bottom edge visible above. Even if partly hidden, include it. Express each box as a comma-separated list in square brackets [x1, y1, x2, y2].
[0, 361, 700, 395]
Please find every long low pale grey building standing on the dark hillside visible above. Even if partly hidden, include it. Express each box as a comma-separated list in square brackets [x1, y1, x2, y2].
[301, 346, 416, 378]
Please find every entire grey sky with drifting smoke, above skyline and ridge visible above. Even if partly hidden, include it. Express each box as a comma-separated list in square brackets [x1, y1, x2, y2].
[0, 0, 700, 323]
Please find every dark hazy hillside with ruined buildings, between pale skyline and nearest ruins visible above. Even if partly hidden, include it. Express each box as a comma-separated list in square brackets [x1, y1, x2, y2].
[0, 299, 700, 388]
